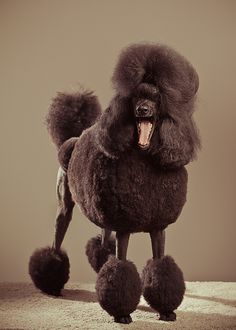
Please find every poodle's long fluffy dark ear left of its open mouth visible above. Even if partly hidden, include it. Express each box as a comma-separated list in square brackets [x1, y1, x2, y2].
[98, 95, 135, 157]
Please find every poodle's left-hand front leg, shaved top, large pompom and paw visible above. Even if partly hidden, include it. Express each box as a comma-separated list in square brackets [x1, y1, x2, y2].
[96, 232, 141, 323]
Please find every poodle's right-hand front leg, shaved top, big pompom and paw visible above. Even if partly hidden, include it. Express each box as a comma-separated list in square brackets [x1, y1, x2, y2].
[142, 231, 185, 321]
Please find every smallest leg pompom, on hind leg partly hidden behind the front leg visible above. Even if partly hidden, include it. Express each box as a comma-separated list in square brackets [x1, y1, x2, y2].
[85, 235, 116, 273]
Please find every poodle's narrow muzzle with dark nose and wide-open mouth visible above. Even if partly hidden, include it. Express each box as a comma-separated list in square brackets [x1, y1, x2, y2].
[135, 99, 156, 149]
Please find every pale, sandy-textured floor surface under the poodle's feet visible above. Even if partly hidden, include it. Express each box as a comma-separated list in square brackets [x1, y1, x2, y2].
[0, 282, 236, 330]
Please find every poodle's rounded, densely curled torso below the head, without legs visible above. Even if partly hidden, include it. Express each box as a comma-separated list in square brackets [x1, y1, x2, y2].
[67, 123, 187, 233]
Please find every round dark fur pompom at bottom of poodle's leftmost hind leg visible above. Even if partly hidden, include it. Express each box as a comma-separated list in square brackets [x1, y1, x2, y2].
[29, 246, 70, 296]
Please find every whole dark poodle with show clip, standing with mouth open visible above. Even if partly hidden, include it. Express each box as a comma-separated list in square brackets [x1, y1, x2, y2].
[29, 43, 200, 323]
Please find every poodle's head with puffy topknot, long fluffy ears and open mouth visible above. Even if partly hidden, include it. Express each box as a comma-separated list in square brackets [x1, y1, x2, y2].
[98, 44, 200, 167]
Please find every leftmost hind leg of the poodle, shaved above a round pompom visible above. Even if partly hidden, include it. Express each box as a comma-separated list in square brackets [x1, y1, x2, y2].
[29, 169, 74, 296]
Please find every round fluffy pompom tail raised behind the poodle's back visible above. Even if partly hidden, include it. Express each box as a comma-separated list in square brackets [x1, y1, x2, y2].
[46, 90, 101, 149]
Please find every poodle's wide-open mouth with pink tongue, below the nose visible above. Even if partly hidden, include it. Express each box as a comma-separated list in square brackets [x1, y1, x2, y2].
[137, 117, 154, 150]
